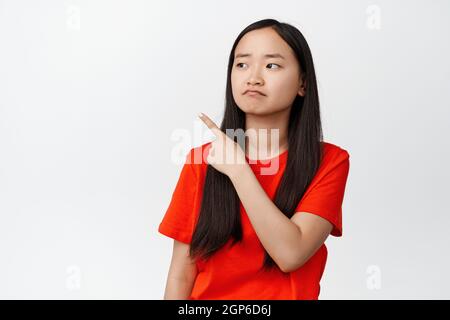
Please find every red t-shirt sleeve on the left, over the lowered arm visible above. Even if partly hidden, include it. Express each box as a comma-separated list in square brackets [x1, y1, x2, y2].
[158, 150, 198, 243]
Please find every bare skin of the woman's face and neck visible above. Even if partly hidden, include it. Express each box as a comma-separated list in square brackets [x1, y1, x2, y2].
[231, 28, 306, 157]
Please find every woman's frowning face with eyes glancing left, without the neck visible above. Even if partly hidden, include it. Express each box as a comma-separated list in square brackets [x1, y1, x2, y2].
[231, 28, 305, 115]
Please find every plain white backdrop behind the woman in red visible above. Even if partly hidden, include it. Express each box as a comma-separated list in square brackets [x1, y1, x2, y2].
[0, 0, 450, 299]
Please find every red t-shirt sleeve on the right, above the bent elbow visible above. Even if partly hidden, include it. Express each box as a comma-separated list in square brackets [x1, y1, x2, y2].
[294, 149, 350, 237]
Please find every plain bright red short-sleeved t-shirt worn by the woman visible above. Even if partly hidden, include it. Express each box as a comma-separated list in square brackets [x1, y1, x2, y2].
[158, 142, 349, 300]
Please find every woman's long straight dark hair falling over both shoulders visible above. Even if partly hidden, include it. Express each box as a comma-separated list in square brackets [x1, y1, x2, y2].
[190, 19, 323, 271]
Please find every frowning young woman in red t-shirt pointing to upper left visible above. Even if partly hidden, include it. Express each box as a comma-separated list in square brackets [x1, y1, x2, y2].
[158, 19, 349, 300]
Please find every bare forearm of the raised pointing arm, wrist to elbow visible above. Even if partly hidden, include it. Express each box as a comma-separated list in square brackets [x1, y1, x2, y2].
[230, 166, 301, 270]
